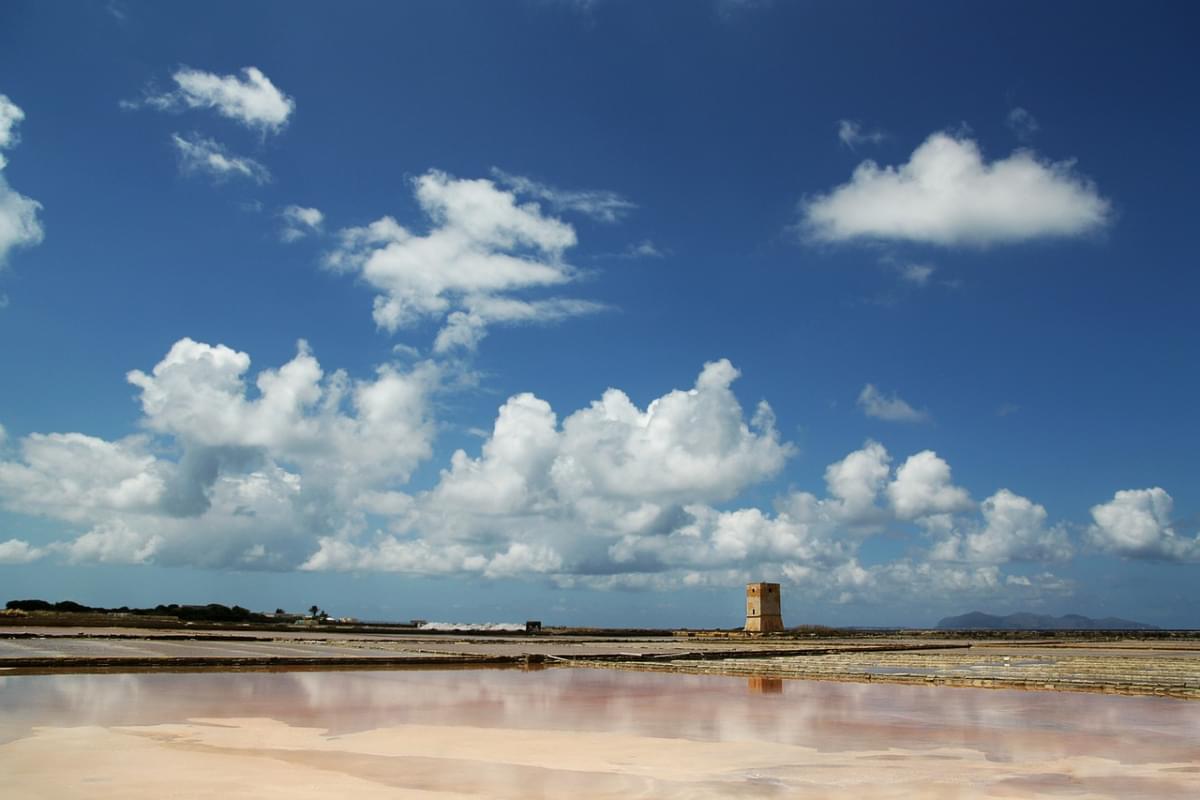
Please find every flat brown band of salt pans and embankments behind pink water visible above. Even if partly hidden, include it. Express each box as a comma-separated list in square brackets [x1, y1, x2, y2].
[0, 626, 1200, 699]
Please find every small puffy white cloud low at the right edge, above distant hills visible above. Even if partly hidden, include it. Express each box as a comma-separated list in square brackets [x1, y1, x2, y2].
[1088, 487, 1200, 561]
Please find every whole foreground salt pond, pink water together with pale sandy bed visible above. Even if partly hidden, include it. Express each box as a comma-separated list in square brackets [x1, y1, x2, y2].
[0, 669, 1200, 800]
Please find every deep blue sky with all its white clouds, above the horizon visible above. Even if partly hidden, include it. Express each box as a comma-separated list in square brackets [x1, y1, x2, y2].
[0, 0, 1200, 626]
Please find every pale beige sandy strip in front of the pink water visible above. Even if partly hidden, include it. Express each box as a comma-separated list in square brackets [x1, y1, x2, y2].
[0, 717, 1200, 800]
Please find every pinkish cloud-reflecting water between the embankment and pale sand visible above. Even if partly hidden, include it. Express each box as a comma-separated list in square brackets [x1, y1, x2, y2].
[0, 669, 1200, 796]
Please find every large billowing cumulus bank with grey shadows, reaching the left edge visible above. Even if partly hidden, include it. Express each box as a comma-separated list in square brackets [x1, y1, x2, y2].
[0, 338, 440, 569]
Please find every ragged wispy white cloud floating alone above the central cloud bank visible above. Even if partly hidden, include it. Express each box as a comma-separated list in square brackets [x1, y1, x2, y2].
[325, 170, 601, 353]
